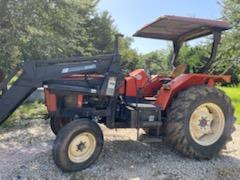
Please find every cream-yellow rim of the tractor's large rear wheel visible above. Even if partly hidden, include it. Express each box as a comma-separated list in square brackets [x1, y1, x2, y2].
[189, 103, 225, 146]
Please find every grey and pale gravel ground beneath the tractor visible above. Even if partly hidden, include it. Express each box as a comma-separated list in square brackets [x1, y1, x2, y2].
[0, 120, 240, 180]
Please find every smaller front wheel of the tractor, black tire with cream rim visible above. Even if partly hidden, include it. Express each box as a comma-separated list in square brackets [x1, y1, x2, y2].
[53, 119, 103, 172]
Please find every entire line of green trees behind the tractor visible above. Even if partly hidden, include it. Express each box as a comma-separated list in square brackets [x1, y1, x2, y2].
[0, 0, 240, 84]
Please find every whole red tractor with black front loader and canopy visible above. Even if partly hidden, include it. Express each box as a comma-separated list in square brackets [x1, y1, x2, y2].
[0, 16, 235, 171]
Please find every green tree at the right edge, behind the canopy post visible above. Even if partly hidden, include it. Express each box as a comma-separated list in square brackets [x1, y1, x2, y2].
[211, 0, 240, 84]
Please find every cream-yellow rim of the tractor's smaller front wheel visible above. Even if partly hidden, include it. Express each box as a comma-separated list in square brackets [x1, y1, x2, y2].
[68, 132, 96, 163]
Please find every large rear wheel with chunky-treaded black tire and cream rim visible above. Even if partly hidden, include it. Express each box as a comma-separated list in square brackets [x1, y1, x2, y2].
[165, 86, 235, 159]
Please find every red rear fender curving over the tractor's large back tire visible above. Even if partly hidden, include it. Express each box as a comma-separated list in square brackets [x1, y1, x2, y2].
[156, 74, 231, 110]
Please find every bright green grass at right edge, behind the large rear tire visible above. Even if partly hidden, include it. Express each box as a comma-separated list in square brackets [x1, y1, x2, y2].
[220, 86, 240, 124]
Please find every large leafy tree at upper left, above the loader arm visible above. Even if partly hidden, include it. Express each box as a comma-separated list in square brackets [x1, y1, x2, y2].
[0, 0, 117, 73]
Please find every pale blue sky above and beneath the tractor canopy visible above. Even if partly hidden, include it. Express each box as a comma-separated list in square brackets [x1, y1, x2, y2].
[98, 0, 221, 53]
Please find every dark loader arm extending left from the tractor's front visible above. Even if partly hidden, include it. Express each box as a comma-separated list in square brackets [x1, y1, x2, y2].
[0, 54, 120, 124]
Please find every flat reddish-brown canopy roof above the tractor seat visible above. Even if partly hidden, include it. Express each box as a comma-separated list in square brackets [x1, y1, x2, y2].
[134, 16, 230, 41]
